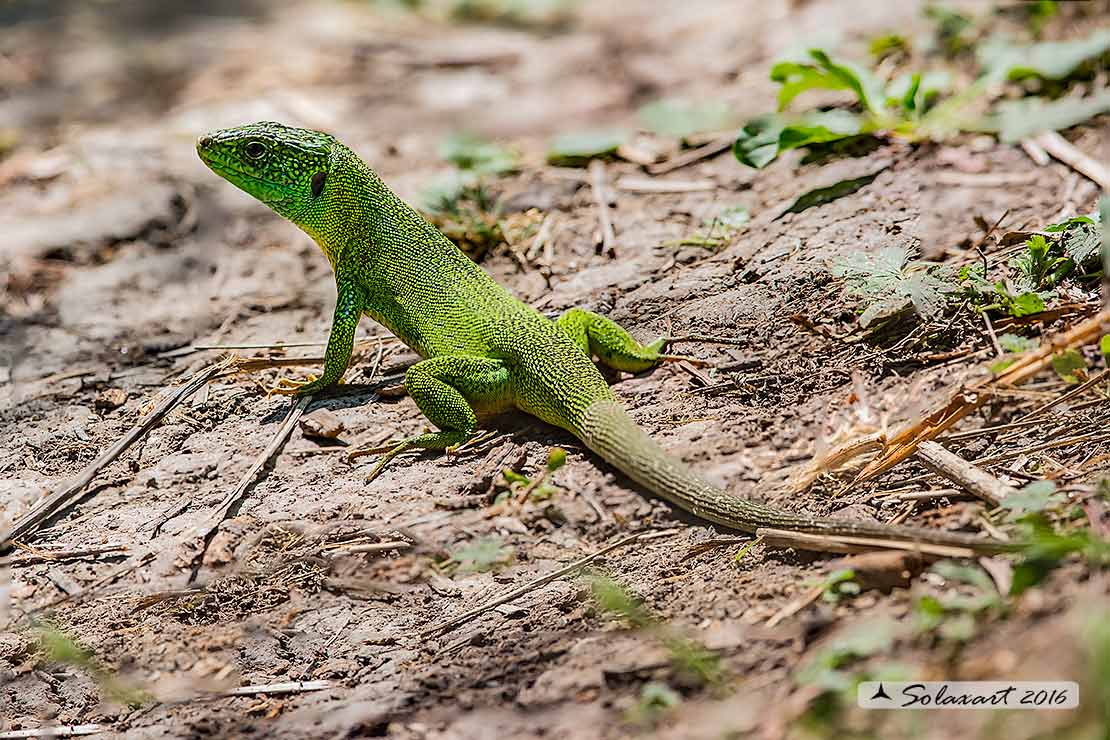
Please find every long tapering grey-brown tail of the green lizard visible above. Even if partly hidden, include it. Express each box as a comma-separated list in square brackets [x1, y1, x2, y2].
[577, 399, 1012, 551]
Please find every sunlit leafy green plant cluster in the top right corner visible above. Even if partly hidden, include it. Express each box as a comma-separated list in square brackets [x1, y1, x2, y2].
[733, 28, 1110, 169]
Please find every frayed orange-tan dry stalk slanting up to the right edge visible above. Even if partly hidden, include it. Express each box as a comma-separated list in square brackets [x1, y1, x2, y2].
[855, 310, 1110, 484]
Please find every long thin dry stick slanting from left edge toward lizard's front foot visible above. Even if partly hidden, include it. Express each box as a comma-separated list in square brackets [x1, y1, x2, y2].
[0, 362, 228, 550]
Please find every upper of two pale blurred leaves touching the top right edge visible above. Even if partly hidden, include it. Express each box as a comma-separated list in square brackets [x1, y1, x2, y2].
[977, 30, 1110, 81]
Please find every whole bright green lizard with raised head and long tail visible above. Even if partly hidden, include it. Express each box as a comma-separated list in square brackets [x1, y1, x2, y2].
[196, 122, 1002, 550]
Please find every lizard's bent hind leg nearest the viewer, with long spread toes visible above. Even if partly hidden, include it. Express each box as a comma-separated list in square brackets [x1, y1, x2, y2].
[347, 355, 513, 483]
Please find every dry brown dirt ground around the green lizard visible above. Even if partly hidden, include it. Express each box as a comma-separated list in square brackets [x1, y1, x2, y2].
[0, 0, 1110, 738]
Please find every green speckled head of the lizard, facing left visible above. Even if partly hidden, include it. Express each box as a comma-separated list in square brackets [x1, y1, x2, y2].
[196, 121, 335, 222]
